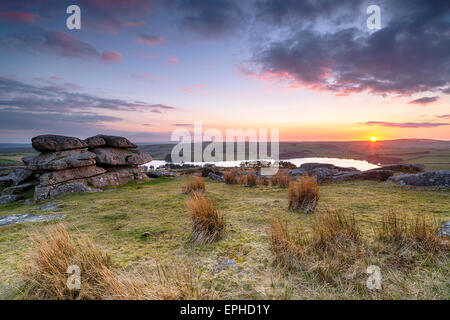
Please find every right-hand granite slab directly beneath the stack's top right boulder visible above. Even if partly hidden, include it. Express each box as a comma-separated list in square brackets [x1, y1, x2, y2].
[91, 147, 152, 166]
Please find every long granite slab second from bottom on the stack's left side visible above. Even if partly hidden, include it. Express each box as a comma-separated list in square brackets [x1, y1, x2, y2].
[39, 166, 106, 186]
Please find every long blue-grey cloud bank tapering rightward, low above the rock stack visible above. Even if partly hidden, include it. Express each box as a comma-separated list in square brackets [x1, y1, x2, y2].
[0, 77, 175, 132]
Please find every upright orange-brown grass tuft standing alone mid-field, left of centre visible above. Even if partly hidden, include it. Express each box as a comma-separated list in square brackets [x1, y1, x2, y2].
[186, 193, 225, 243]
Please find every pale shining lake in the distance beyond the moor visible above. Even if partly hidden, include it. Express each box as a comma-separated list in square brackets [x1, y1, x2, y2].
[145, 158, 379, 171]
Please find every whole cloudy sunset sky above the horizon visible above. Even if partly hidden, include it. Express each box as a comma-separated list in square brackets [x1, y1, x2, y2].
[0, 0, 450, 143]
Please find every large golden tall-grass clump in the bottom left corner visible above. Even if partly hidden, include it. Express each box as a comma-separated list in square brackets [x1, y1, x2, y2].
[21, 225, 112, 300]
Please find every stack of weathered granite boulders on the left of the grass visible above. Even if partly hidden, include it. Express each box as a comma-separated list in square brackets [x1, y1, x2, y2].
[22, 135, 152, 201]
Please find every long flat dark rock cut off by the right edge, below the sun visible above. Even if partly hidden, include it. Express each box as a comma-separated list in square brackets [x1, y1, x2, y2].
[389, 170, 450, 188]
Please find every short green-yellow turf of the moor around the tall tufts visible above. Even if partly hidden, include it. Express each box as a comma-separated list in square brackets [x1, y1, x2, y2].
[0, 178, 450, 299]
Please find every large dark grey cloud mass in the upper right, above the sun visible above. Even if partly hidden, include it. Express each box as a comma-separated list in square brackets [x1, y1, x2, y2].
[252, 0, 450, 95]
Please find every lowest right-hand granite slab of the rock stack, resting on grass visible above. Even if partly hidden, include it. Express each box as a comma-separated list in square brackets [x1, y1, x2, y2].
[87, 167, 149, 188]
